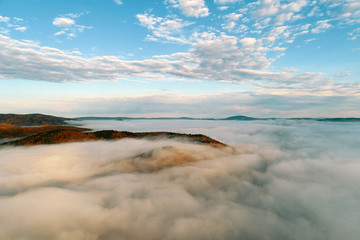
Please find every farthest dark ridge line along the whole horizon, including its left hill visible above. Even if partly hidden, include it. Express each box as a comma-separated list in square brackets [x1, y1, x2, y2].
[0, 113, 360, 126]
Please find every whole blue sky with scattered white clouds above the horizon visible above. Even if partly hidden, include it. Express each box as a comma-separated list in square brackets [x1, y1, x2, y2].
[0, 0, 360, 117]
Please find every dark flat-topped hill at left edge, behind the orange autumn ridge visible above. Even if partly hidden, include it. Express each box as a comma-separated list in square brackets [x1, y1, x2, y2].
[0, 113, 70, 126]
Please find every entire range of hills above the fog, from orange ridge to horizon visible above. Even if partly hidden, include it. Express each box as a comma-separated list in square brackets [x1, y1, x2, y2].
[0, 114, 360, 147]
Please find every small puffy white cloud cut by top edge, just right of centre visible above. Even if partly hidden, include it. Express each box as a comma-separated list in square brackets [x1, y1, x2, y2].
[168, 0, 209, 18]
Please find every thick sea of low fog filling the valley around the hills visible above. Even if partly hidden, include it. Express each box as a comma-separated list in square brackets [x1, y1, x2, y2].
[0, 120, 360, 240]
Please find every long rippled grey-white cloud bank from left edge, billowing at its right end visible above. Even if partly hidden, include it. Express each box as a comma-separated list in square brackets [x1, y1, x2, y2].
[0, 32, 316, 83]
